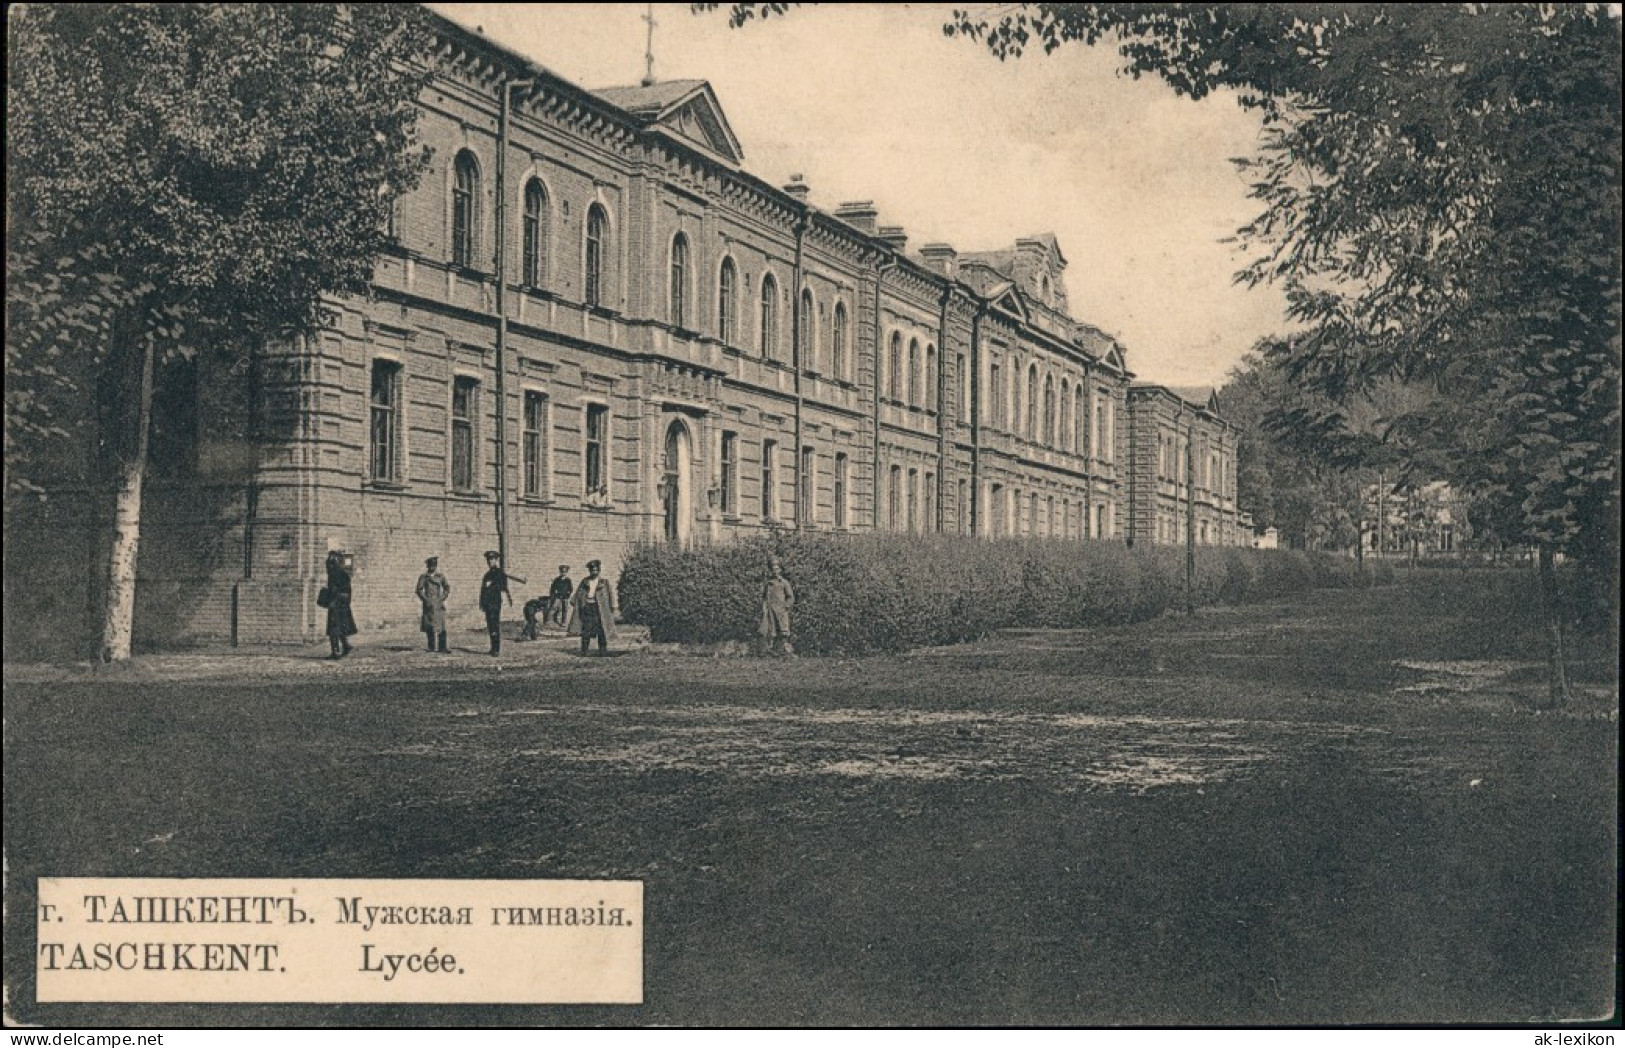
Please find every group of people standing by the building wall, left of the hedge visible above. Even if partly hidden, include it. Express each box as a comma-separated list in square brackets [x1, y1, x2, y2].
[317, 549, 618, 660]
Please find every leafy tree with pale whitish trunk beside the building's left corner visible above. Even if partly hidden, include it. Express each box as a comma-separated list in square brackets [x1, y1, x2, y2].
[7, 5, 427, 661]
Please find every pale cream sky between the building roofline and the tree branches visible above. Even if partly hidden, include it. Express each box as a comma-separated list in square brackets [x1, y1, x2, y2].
[429, 3, 1287, 385]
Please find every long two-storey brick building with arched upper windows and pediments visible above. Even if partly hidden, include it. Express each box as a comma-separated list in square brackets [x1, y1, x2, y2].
[8, 8, 1238, 640]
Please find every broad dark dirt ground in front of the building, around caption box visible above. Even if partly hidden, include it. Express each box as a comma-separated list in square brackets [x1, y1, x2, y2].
[5, 572, 1619, 1025]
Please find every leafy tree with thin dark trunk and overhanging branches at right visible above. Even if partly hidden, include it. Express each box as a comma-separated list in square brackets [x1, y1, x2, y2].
[700, 3, 1622, 702]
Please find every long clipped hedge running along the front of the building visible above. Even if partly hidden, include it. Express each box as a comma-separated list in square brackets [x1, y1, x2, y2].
[621, 533, 1393, 653]
